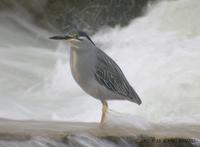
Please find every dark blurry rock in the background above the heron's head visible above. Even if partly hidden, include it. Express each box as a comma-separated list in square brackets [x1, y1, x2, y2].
[0, 0, 156, 32]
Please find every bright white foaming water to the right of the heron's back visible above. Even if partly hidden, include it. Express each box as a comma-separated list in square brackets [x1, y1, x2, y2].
[94, 0, 200, 124]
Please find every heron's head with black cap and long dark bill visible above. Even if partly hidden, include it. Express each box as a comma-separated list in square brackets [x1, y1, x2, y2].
[50, 31, 95, 48]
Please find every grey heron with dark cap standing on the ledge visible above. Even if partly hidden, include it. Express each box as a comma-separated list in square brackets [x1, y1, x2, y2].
[50, 31, 142, 125]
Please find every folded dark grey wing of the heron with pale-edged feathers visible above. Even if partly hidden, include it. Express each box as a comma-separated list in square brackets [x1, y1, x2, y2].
[95, 49, 141, 104]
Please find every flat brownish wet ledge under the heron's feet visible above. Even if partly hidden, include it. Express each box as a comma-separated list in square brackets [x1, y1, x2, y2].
[0, 119, 200, 147]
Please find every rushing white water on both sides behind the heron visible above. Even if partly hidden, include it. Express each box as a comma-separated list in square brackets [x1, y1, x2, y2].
[0, 0, 200, 146]
